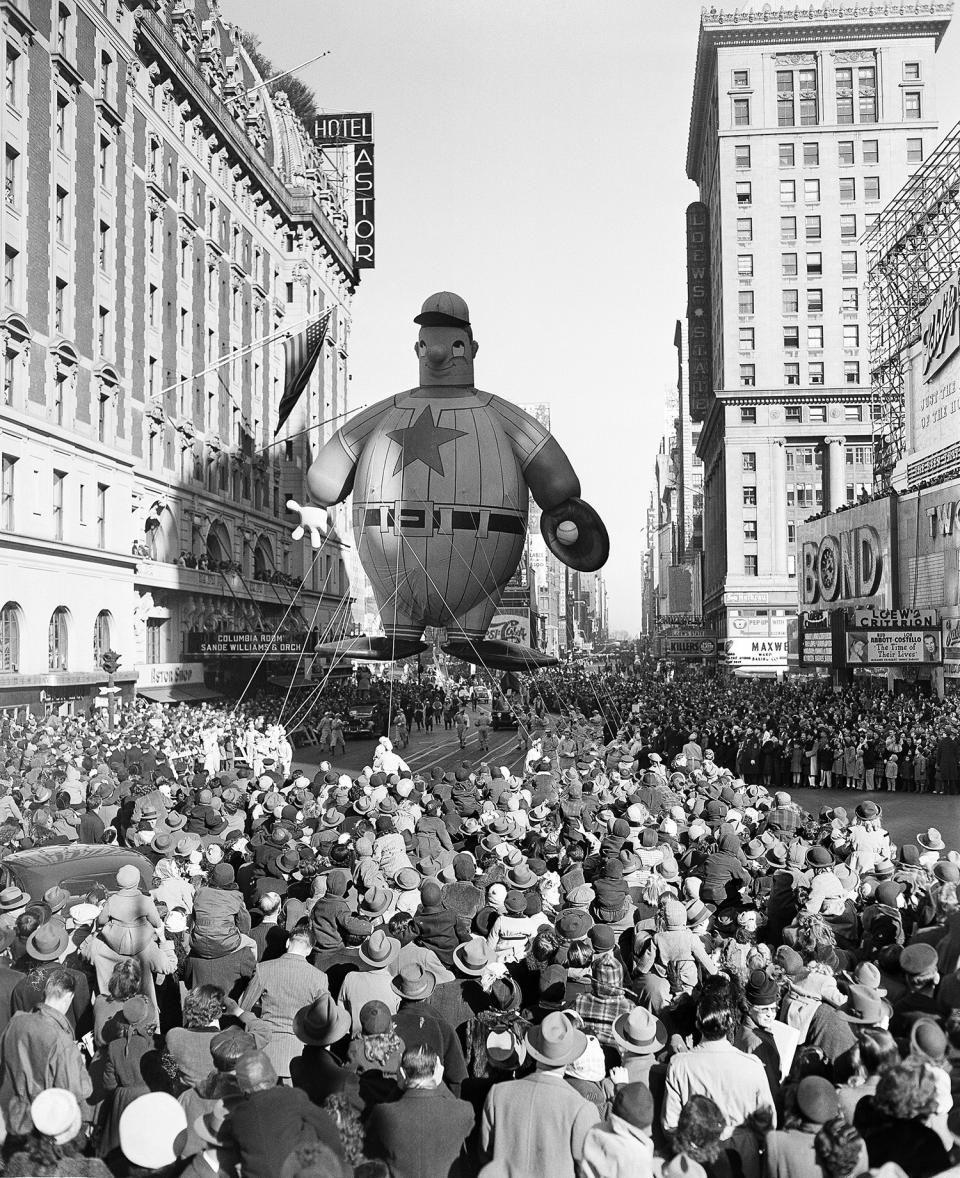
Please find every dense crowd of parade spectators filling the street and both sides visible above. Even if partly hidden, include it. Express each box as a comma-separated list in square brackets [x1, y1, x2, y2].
[0, 667, 960, 1178]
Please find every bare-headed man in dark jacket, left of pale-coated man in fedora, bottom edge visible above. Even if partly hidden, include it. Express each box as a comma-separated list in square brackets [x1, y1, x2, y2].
[368, 1044, 476, 1178]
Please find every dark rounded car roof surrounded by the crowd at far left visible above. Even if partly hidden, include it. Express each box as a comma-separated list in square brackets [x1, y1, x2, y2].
[0, 843, 153, 900]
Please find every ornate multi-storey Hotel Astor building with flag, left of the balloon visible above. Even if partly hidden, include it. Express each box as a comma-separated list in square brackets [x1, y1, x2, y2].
[0, 0, 358, 709]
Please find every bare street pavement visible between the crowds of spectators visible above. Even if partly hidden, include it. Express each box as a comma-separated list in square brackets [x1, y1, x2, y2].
[293, 715, 960, 849]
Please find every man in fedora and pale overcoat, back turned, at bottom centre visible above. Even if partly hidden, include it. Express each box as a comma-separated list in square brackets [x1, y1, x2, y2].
[481, 1011, 600, 1178]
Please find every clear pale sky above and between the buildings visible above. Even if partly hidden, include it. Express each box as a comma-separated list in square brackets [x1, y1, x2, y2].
[221, 0, 960, 633]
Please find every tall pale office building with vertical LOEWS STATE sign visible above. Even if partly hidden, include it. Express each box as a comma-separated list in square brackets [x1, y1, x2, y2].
[687, 0, 953, 670]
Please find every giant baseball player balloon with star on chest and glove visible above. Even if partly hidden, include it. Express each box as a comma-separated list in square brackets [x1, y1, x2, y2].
[287, 291, 610, 669]
